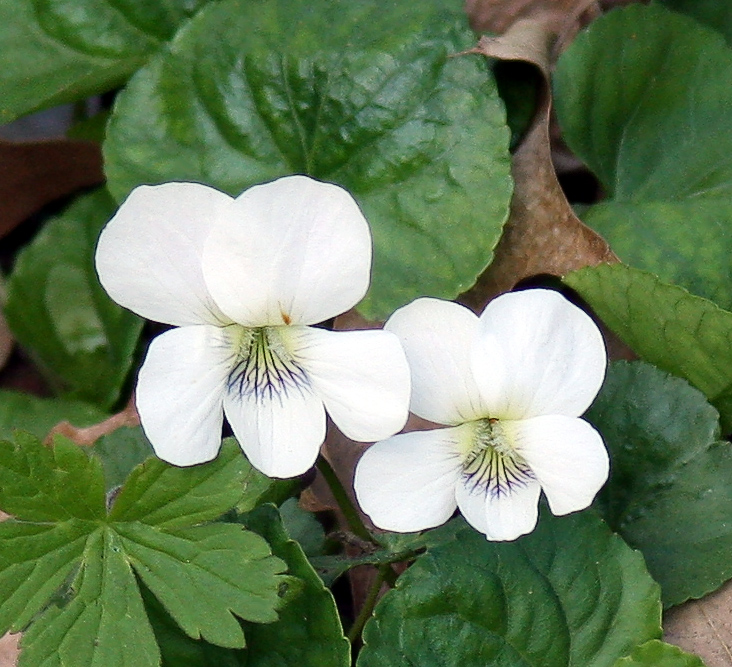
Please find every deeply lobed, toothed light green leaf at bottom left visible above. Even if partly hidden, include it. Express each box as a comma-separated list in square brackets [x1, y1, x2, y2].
[0, 432, 295, 667]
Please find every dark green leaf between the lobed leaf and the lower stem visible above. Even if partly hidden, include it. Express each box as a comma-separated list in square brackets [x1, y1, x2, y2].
[244, 505, 351, 667]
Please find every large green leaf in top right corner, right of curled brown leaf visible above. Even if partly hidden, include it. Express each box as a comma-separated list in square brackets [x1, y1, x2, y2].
[555, 3, 732, 308]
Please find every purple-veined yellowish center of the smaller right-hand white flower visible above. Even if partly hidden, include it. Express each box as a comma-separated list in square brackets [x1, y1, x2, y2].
[463, 419, 536, 498]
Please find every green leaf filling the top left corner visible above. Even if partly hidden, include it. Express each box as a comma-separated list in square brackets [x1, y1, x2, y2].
[0, 0, 209, 124]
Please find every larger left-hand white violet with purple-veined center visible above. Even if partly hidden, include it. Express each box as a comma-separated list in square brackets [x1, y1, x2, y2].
[96, 176, 410, 477]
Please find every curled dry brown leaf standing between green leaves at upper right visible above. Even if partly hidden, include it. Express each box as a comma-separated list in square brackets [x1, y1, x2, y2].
[461, 12, 618, 311]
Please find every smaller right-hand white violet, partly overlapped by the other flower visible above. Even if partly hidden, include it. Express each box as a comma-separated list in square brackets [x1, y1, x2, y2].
[354, 289, 608, 540]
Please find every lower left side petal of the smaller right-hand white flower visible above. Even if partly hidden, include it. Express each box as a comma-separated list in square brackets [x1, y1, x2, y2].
[353, 428, 460, 533]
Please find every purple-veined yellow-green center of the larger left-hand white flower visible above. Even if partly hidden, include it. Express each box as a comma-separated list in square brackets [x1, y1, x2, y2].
[229, 327, 309, 400]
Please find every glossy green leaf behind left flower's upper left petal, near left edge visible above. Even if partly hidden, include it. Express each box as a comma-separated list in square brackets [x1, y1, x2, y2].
[5, 190, 142, 408]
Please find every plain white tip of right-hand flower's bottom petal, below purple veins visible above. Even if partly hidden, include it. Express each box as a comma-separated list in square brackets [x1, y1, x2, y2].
[456, 480, 541, 541]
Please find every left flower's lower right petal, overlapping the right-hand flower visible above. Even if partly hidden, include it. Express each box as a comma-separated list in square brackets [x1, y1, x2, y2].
[296, 327, 410, 442]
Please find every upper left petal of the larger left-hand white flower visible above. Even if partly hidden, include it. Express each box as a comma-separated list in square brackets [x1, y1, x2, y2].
[96, 183, 234, 326]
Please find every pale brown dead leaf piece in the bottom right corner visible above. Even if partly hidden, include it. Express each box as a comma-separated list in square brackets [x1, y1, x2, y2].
[663, 582, 732, 667]
